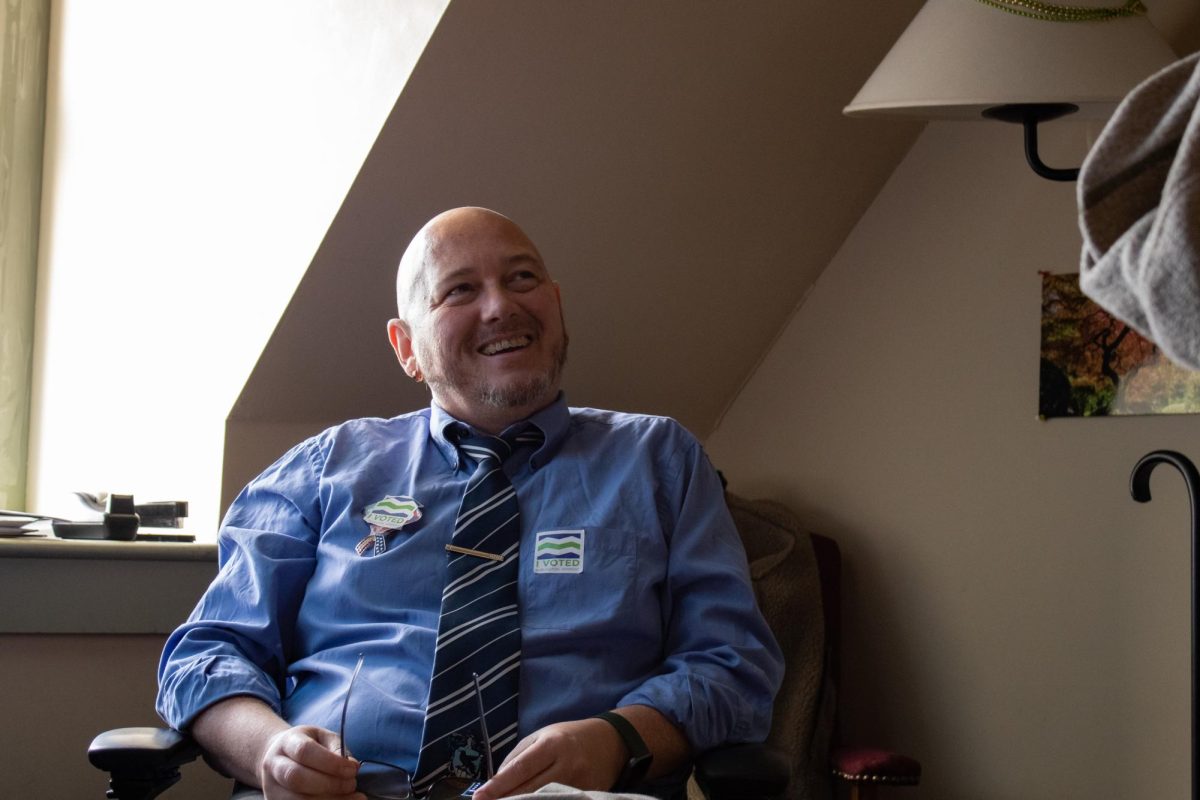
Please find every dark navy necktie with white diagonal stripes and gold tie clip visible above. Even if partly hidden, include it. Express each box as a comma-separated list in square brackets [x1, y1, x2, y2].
[413, 427, 544, 794]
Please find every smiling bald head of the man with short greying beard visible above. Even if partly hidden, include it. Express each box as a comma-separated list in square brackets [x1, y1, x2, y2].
[388, 209, 568, 433]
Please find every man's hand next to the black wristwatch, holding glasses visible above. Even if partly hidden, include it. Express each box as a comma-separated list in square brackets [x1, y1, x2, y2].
[475, 720, 626, 800]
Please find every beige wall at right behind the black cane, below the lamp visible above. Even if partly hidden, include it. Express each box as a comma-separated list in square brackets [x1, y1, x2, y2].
[707, 122, 1200, 800]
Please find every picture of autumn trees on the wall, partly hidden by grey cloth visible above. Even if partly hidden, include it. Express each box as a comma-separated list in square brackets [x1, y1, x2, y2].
[1038, 272, 1200, 419]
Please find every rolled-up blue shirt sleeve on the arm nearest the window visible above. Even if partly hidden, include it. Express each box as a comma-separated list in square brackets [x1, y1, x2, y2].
[156, 439, 331, 729]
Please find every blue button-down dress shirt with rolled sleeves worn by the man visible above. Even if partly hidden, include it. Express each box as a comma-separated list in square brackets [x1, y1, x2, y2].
[157, 395, 782, 770]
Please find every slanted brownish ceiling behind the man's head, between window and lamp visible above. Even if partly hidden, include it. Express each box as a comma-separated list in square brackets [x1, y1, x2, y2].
[226, 0, 922, 500]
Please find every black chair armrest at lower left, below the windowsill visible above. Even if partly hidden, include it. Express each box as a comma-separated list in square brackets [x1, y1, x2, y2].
[88, 728, 200, 800]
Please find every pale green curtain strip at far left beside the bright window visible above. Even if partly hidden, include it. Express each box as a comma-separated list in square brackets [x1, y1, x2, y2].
[0, 0, 50, 510]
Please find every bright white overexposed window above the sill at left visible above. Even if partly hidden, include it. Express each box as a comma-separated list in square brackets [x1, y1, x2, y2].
[28, 0, 449, 537]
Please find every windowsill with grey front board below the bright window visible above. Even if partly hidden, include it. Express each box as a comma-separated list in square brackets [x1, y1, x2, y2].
[0, 537, 217, 633]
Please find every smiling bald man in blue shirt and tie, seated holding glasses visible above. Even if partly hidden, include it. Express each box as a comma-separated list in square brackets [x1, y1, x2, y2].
[158, 207, 782, 800]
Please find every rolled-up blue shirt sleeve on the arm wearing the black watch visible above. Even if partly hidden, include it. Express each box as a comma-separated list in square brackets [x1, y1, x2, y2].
[618, 441, 784, 752]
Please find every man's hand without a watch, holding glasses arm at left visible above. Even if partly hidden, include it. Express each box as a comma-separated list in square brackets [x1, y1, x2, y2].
[258, 726, 365, 800]
